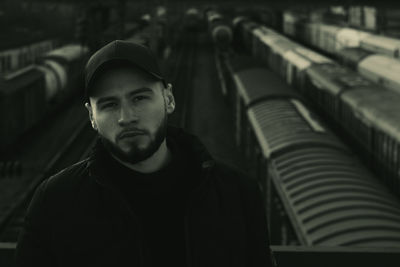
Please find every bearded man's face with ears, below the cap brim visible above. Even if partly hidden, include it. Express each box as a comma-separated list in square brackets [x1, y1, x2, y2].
[86, 68, 175, 164]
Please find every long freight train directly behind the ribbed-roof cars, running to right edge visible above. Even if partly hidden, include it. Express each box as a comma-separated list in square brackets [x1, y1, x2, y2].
[231, 17, 400, 199]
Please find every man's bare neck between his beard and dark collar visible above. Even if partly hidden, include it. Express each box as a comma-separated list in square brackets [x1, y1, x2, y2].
[111, 140, 172, 176]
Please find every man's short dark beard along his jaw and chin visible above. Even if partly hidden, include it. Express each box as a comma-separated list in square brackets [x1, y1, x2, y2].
[99, 113, 168, 164]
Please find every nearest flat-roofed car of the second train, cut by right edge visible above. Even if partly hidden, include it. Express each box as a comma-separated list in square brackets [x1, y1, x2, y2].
[341, 87, 400, 194]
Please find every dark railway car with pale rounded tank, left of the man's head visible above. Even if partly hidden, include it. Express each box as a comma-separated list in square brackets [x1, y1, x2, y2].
[0, 45, 88, 152]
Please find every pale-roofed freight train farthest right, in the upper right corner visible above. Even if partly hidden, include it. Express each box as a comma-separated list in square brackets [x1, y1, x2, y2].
[283, 12, 400, 93]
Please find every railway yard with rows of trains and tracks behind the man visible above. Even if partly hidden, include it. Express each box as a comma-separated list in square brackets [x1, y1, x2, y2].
[0, 1, 400, 267]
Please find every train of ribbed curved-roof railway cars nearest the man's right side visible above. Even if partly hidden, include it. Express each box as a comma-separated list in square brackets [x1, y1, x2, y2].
[219, 55, 400, 247]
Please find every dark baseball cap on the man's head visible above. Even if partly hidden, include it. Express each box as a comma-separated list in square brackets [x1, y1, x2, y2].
[85, 40, 166, 99]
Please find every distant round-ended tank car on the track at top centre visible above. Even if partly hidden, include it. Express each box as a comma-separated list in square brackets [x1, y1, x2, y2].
[206, 10, 233, 51]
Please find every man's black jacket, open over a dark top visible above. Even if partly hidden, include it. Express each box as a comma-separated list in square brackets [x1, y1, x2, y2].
[16, 128, 272, 267]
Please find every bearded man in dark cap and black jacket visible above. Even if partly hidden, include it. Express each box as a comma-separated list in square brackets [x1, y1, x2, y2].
[17, 40, 271, 267]
